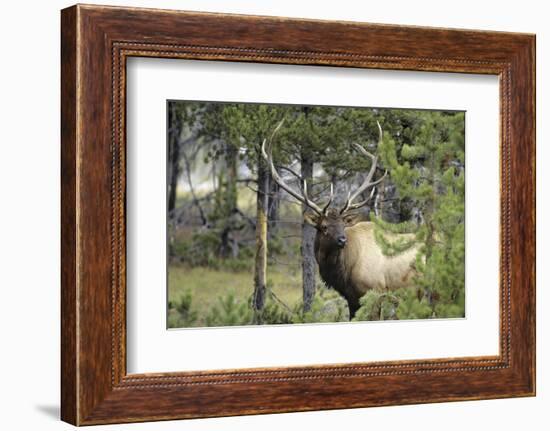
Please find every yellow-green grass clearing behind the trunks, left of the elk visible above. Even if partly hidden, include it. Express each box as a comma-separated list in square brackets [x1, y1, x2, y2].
[168, 265, 302, 326]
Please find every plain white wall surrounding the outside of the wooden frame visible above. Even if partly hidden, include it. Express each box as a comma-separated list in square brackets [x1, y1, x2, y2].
[0, 0, 550, 431]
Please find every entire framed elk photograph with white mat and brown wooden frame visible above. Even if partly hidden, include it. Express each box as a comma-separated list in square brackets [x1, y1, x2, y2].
[61, 5, 535, 425]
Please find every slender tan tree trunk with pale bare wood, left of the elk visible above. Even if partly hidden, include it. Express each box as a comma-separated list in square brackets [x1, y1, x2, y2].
[252, 155, 269, 311]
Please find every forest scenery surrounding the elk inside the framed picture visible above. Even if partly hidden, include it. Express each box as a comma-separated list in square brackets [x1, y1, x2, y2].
[167, 101, 465, 328]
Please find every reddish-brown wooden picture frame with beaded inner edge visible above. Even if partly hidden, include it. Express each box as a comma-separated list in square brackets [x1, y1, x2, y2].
[61, 5, 535, 425]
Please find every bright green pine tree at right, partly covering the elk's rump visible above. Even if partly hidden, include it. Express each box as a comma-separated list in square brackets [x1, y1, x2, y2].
[377, 112, 465, 317]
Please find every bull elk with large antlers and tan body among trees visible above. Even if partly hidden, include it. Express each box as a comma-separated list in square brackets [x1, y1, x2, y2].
[262, 123, 419, 320]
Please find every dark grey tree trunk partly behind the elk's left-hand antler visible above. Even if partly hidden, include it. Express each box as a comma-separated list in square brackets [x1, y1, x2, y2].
[301, 152, 316, 312]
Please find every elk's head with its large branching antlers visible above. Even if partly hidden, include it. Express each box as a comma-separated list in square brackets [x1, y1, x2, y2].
[262, 121, 387, 248]
